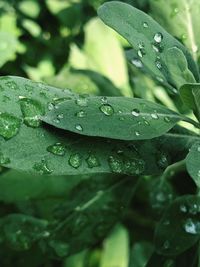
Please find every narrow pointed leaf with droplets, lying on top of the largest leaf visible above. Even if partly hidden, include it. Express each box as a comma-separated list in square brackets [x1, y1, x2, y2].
[42, 96, 182, 140]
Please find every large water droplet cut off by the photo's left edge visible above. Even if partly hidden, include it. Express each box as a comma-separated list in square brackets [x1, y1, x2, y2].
[0, 113, 21, 139]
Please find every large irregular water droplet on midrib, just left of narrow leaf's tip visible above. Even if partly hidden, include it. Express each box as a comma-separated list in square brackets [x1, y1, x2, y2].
[20, 98, 44, 128]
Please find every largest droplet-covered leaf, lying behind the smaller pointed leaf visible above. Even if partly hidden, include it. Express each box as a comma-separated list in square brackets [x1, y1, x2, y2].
[0, 77, 198, 175]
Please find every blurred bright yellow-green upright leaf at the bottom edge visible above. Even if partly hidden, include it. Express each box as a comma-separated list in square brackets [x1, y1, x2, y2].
[100, 225, 129, 267]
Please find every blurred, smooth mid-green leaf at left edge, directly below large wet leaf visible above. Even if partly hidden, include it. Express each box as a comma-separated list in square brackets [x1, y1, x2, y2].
[0, 170, 83, 203]
